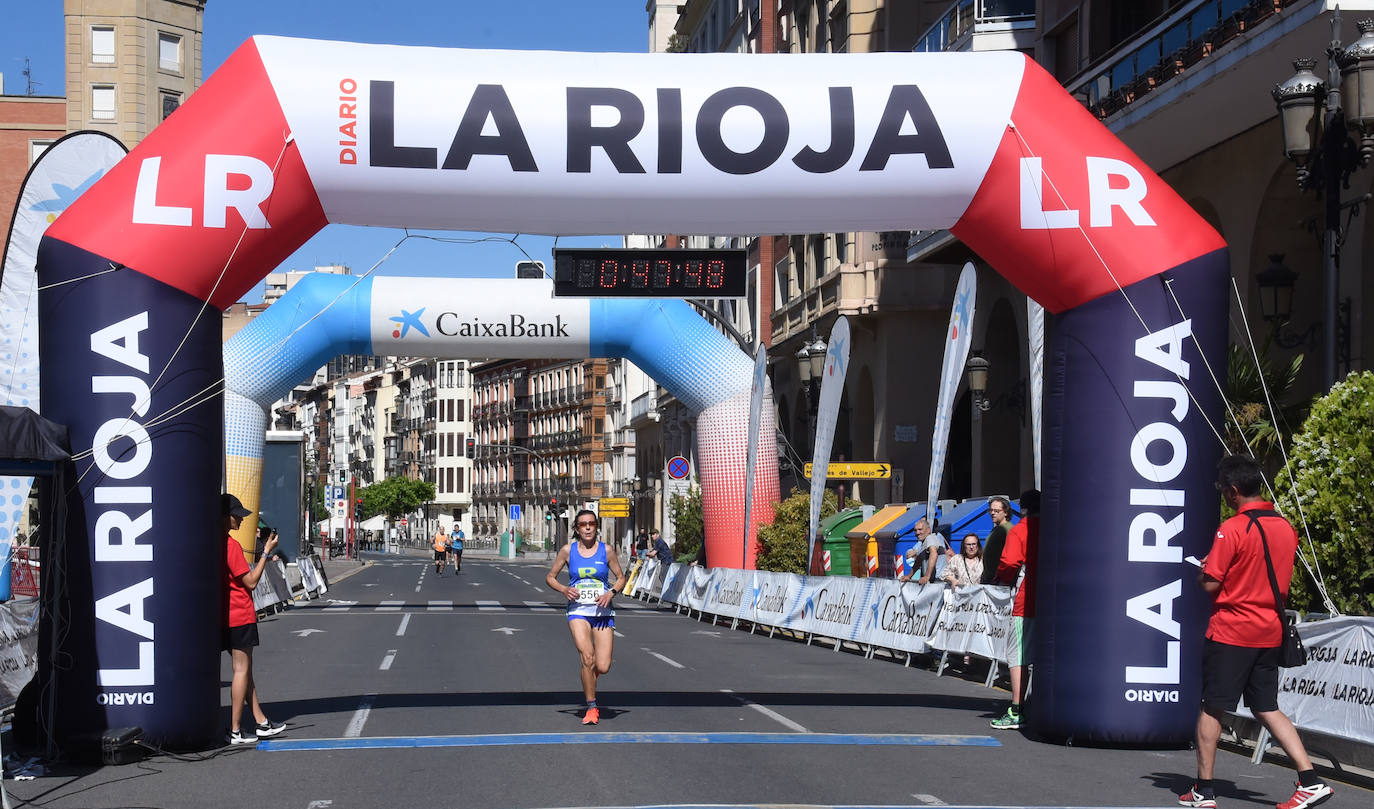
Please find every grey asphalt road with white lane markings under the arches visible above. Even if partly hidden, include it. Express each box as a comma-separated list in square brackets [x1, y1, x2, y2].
[5, 558, 1374, 809]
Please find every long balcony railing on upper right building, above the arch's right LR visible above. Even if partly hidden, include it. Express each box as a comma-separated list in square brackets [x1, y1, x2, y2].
[1068, 0, 1280, 118]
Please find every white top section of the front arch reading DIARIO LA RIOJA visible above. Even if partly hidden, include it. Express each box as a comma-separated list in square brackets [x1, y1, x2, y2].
[253, 36, 1025, 235]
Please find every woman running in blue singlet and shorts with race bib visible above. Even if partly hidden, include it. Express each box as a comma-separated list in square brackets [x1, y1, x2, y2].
[544, 508, 625, 725]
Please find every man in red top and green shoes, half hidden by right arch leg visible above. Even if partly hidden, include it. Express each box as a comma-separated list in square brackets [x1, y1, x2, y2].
[989, 489, 1040, 731]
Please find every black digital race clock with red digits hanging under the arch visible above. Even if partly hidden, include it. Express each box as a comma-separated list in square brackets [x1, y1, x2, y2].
[554, 247, 749, 298]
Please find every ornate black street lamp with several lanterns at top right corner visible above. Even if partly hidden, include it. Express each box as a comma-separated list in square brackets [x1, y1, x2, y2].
[1261, 8, 1374, 389]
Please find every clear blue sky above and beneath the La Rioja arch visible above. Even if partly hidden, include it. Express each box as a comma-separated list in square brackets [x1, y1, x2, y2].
[0, 0, 649, 302]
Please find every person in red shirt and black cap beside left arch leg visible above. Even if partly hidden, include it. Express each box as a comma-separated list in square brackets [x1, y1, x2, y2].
[220, 494, 286, 744]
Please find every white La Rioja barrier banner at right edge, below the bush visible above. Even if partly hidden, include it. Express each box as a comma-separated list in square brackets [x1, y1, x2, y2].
[1237, 617, 1374, 743]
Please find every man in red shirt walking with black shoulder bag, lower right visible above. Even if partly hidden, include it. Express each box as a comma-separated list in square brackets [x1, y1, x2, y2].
[1179, 455, 1331, 809]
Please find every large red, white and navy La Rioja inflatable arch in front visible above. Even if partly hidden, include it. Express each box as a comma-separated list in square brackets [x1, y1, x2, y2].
[38, 37, 1228, 746]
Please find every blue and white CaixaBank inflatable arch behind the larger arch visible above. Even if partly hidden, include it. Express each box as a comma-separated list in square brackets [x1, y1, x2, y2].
[224, 275, 778, 554]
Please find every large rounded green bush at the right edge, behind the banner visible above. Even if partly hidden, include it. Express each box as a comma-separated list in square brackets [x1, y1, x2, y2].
[1274, 371, 1374, 615]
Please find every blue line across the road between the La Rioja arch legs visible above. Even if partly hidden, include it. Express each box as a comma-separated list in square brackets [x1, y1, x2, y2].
[265, 732, 1002, 753]
